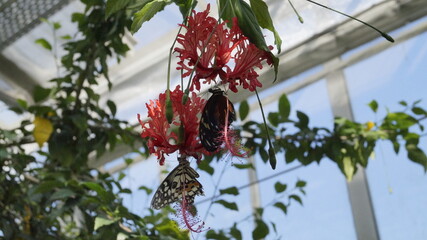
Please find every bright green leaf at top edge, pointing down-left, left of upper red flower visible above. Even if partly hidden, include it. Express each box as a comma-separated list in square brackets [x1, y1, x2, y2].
[131, 0, 172, 33]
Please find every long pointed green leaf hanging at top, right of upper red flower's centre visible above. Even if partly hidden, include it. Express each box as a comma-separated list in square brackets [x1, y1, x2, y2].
[250, 0, 282, 53]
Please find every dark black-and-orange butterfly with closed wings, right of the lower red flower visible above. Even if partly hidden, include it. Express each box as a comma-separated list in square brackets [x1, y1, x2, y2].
[199, 88, 236, 152]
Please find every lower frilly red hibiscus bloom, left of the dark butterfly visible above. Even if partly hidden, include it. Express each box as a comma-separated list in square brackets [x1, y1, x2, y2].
[138, 86, 206, 165]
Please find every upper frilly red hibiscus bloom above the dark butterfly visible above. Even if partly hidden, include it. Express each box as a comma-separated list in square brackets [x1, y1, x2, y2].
[175, 5, 272, 92]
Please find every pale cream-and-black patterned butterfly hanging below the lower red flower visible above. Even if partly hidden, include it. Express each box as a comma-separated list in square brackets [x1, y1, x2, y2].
[151, 158, 204, 209]
